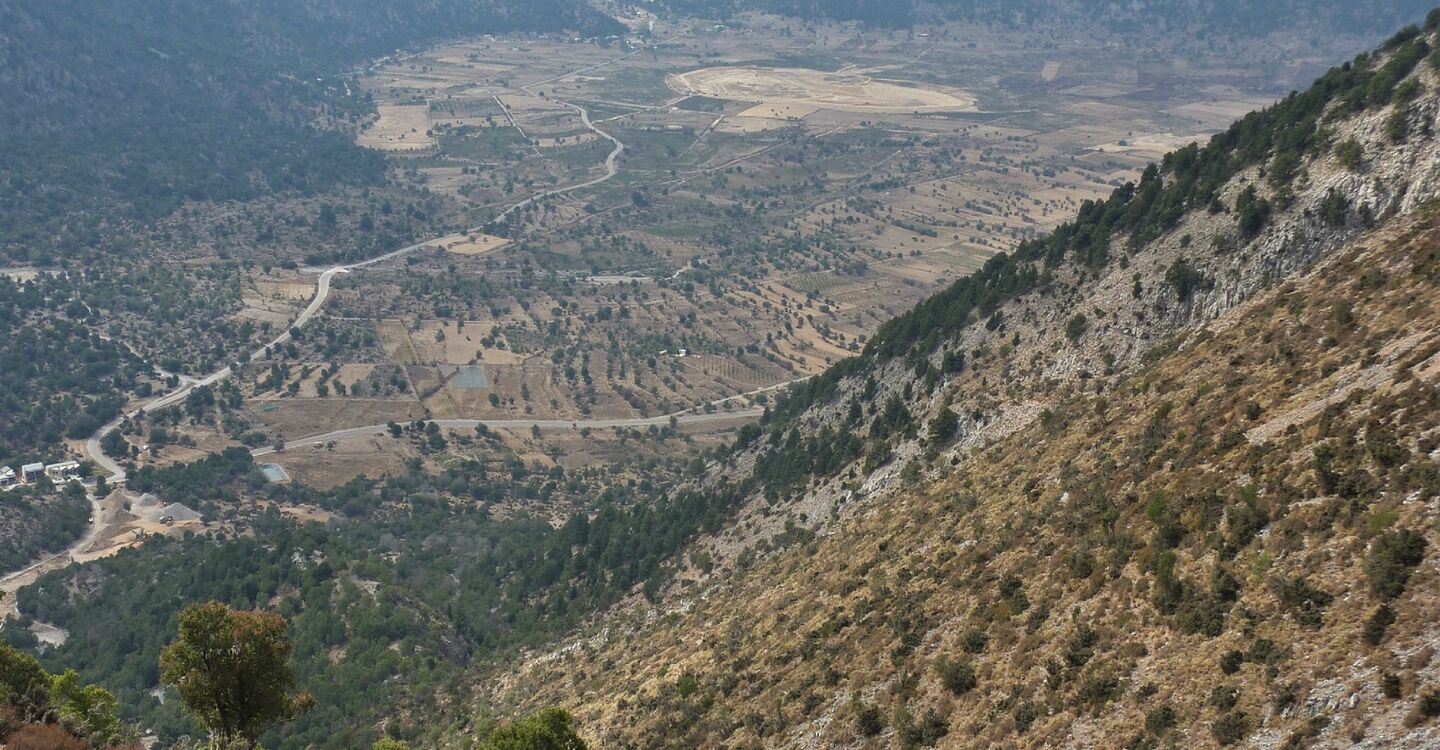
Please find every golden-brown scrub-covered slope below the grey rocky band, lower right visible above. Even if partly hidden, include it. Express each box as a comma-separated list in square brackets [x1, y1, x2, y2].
[484, 156, 1440, 749]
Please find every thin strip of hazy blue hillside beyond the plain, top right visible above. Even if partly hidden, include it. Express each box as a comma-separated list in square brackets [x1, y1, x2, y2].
[665, 0, 1430, 35]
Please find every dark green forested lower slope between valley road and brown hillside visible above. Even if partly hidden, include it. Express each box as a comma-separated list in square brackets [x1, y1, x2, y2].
[3, 448, 744, 749]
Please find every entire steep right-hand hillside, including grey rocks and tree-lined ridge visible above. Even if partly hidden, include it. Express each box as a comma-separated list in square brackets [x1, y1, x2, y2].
[466, 16, 1440, 747]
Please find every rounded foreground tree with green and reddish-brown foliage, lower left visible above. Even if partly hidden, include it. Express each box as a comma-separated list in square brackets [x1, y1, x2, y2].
[160, 602, 315, 749]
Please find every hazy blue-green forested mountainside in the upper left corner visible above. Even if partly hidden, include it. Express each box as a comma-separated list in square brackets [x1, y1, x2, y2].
[0, 0, 616, 259]
